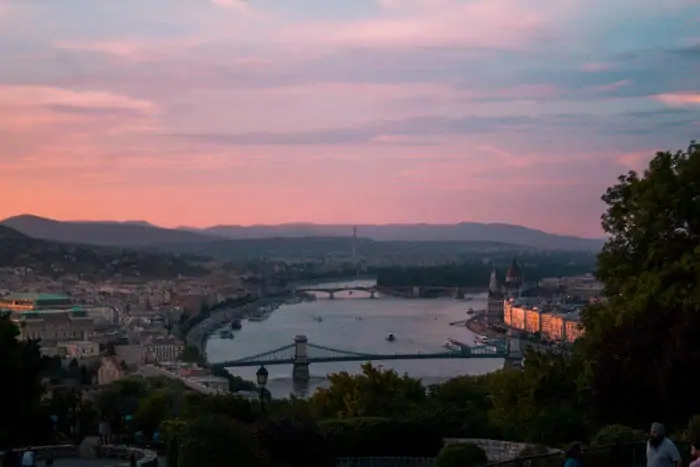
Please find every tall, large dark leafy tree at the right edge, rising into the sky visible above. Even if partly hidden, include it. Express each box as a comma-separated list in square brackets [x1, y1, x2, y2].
[583, 143, 700, 426]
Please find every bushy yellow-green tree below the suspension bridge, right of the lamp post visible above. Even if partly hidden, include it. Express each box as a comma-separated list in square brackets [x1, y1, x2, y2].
[311, 363, 426, 417]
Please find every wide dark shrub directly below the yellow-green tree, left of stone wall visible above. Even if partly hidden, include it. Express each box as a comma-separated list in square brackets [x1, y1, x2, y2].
[319, 417, 442, 457]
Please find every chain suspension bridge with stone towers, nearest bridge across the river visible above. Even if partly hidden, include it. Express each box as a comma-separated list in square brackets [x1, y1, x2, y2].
[212, 336, 520, 381]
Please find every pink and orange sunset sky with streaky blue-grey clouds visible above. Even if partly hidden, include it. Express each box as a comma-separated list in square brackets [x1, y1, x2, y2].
[0, 0, 700, 237]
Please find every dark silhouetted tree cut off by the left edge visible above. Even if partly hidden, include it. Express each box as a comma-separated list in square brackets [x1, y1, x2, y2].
[0, 315, 50, 448]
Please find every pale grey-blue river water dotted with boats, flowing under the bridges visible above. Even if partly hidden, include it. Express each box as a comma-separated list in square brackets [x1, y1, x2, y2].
[206, 280, 503, 397]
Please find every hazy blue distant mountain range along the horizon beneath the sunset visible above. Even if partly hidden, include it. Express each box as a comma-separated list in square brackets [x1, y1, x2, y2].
[0, 215, 603, 251]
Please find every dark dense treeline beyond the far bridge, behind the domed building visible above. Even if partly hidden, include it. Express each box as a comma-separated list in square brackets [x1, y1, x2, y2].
[377, 252, 596, 288]
